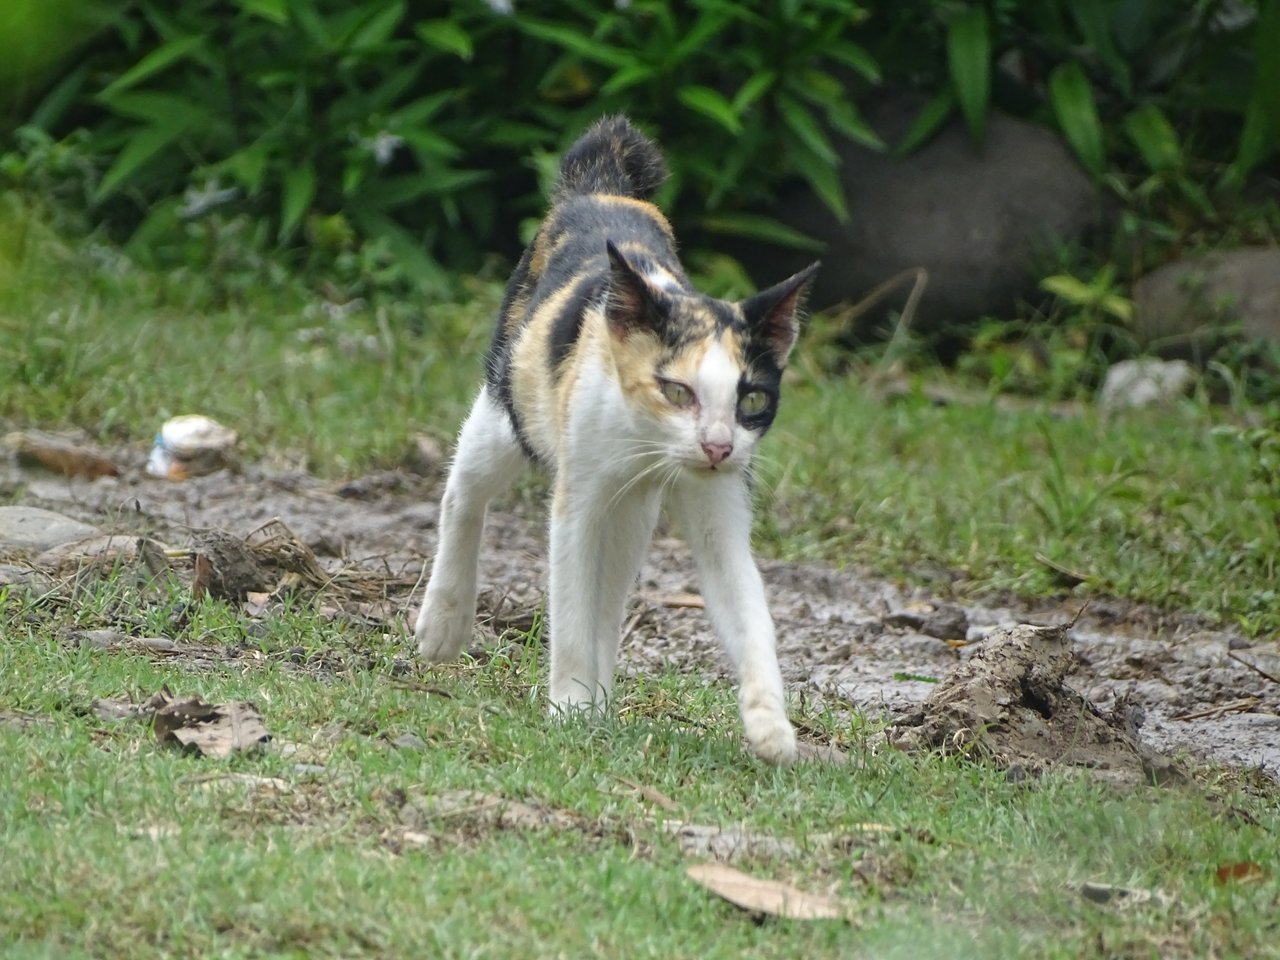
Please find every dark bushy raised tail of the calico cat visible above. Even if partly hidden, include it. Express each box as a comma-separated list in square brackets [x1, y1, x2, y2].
[554, 116, 667, 200]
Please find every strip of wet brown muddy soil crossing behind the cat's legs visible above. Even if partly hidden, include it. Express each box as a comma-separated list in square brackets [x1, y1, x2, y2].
[0, 455, 1280, 780]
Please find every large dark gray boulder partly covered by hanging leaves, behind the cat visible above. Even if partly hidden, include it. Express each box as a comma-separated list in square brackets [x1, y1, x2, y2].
[740, 93, 1101, 328]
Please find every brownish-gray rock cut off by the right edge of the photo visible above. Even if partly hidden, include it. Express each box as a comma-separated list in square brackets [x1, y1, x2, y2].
[1133, 247, 1280, 353]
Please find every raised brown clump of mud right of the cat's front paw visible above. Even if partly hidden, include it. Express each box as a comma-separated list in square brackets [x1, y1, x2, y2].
[890, 623, 1183, 785]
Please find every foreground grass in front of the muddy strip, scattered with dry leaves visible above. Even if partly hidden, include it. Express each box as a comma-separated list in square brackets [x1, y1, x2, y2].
[0, 584, 1280, 957]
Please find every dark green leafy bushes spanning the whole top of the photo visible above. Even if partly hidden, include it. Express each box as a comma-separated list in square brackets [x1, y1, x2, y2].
[0, 0, 1280, 316]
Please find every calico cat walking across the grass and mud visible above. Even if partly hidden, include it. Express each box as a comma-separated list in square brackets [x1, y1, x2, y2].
[415, 116, 818, 763]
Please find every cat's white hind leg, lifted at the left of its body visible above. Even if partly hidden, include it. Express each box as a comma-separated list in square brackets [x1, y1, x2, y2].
[413, 388, 526, 660]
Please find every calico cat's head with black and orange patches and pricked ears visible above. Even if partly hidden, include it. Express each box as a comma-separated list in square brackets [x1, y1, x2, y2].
[605, 243, 818, 471]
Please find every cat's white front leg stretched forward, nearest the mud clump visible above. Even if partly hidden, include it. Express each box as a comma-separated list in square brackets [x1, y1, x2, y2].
[671, 472, 796, 764]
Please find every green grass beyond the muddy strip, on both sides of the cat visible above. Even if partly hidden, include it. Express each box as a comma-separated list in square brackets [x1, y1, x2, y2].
[0, 192, 1280, 637]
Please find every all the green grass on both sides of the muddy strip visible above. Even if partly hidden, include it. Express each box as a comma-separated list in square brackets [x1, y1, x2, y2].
[0, 198, 1280, 957]
